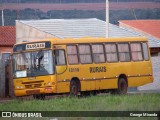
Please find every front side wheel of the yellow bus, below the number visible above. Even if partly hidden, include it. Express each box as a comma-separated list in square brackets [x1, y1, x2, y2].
[70, 80, 78, 96]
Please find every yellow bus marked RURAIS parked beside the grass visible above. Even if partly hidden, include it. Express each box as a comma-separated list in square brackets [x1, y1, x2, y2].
[13, 37, 153, 98]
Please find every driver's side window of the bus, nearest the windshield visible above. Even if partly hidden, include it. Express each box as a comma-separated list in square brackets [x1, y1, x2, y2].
[55, 50, 66, 65]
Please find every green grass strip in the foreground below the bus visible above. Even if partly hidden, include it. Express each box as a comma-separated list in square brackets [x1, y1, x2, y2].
[0, 94, 160, 120]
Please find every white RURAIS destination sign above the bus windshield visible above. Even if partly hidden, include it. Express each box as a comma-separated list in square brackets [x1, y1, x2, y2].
[26, 43, 45, 50]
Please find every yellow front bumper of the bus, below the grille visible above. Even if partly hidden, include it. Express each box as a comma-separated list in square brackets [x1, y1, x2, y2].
[14, 87, 56, 97]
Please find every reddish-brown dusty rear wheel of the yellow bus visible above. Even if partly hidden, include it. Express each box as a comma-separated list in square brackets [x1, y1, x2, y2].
[117, 78, 128, 95]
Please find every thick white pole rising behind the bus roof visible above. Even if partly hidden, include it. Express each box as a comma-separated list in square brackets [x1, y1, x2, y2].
[106, 0, 109, 38]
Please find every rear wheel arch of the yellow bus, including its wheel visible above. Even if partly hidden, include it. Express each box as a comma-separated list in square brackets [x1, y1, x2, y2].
[117, 74, 128, 95]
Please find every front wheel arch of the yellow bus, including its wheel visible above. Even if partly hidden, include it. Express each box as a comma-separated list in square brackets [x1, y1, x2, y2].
[70, 77, 81, 96]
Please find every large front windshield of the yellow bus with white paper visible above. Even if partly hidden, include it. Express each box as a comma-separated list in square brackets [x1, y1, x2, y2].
[13, 50, 54, 78]
